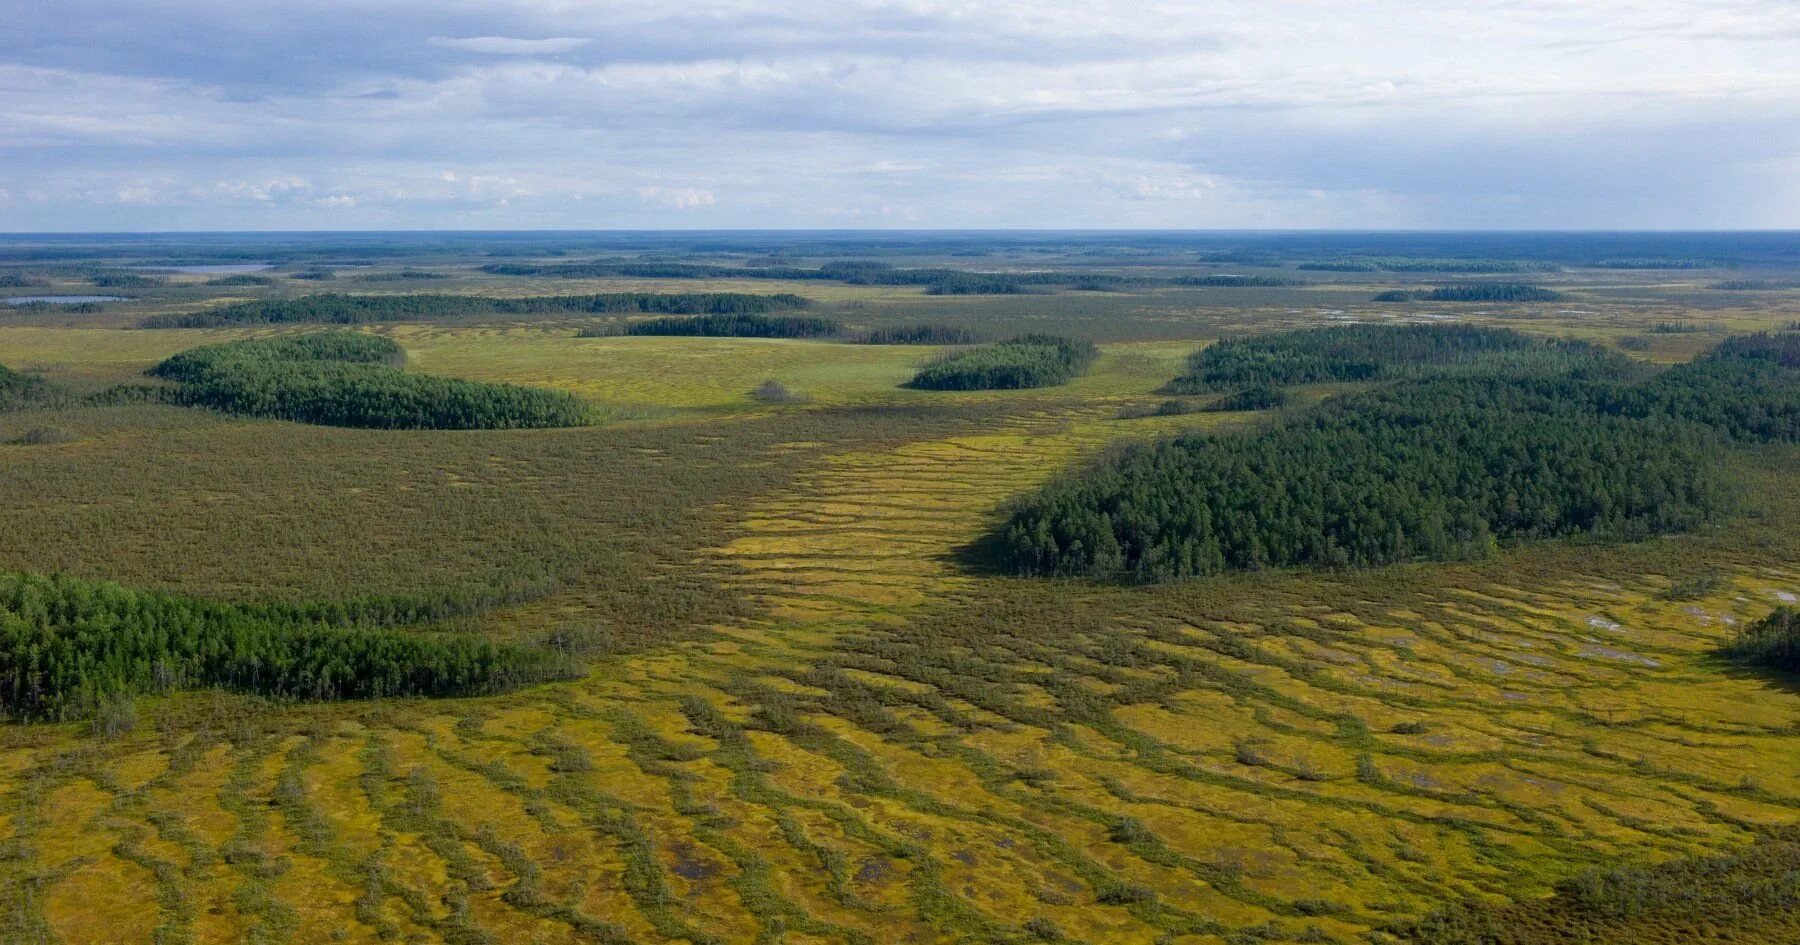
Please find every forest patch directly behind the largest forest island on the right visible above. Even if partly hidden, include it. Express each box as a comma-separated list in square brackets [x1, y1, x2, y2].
[1166, 324, 1606, 394]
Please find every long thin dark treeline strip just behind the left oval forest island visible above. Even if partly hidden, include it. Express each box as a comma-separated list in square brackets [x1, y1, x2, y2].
[144, 292, 812, 328]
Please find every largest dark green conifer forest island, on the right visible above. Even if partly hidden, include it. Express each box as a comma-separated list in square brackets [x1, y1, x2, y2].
[995, 329, 1800, 580]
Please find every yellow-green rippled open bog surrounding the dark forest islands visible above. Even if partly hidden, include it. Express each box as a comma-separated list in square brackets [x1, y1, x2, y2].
[0, 237, 1800, 945]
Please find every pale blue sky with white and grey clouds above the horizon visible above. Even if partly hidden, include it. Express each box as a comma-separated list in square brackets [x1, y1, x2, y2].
[0, 0, 1800, 232]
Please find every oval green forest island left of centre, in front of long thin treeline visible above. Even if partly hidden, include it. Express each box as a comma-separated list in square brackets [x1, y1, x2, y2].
[149, 331, 592, 430]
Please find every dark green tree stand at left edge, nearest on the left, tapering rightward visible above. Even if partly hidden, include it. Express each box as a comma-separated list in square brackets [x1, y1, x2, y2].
[0, 574, 569, 720]
